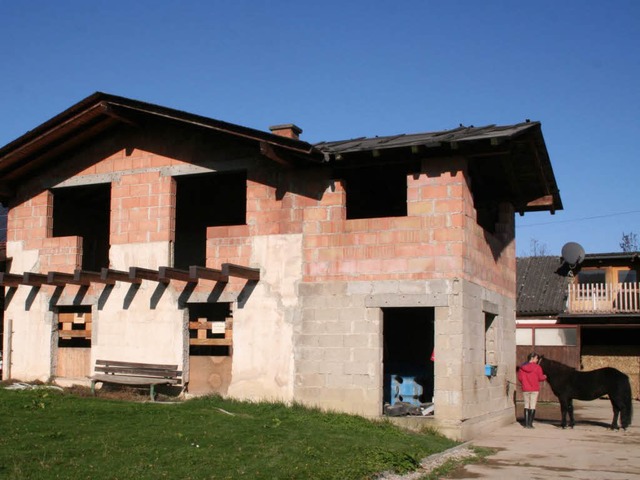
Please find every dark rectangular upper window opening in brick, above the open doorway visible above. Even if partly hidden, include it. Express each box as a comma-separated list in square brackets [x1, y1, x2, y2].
[341, 165, 407, 220]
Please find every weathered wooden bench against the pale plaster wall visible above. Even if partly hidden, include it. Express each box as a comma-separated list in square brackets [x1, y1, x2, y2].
[91, 360, 182, 401]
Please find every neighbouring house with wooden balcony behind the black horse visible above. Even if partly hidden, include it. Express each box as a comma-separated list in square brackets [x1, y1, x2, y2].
[516, 252, 640, 400]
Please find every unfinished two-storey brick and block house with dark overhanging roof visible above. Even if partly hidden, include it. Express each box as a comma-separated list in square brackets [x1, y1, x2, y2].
[0, 93, 562, 439]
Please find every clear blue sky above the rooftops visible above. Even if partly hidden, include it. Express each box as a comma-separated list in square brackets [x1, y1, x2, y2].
[0, 0, 640, 255]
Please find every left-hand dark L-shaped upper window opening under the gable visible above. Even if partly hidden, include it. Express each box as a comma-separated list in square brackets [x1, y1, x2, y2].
[53, 183, 111, 271]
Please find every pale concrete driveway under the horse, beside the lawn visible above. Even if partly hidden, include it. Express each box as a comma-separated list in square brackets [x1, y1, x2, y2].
[447, 400, 640, 480]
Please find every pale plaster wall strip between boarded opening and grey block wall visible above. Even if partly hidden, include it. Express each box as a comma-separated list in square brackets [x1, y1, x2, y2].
[228, 234, 302, 401]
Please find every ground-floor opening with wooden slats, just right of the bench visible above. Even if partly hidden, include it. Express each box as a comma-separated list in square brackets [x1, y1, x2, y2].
[188, 303, 233, 357]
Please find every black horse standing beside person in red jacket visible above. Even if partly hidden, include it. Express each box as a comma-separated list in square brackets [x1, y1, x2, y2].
[538, 357, 633, 430]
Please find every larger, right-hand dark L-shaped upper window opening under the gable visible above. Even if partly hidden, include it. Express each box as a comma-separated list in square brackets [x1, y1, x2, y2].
[174, 172, 247, 269]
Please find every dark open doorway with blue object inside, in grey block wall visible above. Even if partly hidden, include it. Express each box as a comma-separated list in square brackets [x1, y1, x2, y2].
[382, 307, 435, 406]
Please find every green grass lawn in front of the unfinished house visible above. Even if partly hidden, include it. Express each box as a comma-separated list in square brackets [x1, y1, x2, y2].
[0, 388, 456, 480]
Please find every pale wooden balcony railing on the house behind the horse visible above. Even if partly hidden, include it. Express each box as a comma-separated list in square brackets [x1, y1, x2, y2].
[567, 283, 640, 313]
